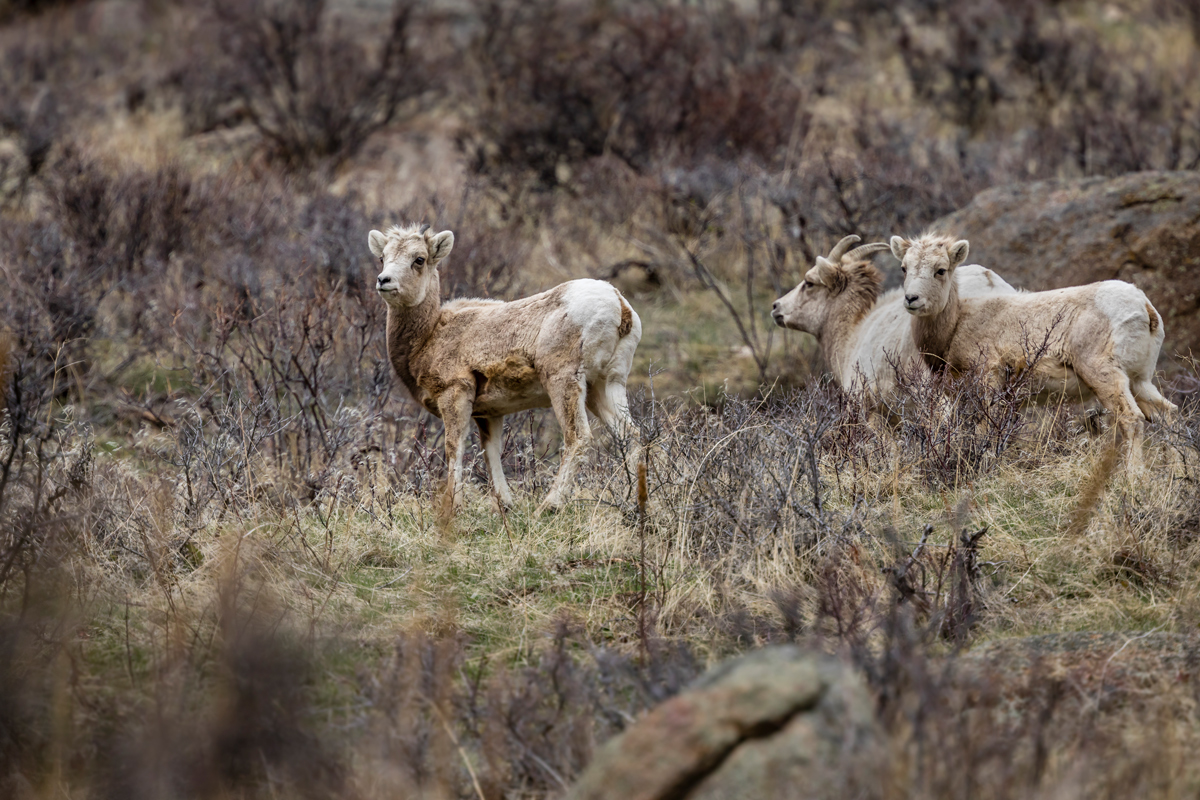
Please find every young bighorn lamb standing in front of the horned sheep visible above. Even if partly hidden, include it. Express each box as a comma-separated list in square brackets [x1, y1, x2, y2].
[892, 234, 1176, 450]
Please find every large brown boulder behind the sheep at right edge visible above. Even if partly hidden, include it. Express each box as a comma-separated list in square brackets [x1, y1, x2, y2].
[934, 172, 1200, 359]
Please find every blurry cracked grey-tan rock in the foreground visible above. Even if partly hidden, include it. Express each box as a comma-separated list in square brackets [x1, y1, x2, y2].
[566, 646, 881, 800]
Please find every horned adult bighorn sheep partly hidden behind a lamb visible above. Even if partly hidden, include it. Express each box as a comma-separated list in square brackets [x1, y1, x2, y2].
[772, 236, 1016, 405]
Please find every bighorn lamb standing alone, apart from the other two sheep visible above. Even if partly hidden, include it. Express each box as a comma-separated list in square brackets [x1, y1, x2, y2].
[367, 225, 642, 521]
